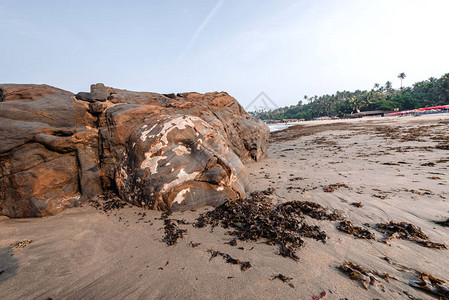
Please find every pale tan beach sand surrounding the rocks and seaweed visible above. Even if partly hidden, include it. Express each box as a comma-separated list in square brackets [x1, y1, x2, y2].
[0, 114, 449, 299]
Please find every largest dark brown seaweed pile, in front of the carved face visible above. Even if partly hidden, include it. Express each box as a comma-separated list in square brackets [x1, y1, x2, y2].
[194, 192, 327, 260]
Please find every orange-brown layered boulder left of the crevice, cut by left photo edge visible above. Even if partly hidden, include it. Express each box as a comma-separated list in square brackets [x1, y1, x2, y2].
[0, 84, 102, 217]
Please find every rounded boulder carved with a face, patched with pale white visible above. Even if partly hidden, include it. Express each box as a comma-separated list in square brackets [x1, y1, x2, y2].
[104, 109, 247, 210]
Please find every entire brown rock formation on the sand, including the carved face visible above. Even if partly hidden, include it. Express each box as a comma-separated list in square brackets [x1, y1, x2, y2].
[0, 84, 269, 217]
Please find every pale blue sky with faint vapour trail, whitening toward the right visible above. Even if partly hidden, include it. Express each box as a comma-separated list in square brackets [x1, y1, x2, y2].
[0, 0, 449, 110]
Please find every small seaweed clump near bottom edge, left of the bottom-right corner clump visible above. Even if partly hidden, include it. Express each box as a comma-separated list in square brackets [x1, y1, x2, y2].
[338, 261, 391, 289]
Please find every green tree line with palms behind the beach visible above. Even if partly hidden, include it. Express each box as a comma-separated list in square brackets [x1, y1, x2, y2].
[249, 73, 449, 120]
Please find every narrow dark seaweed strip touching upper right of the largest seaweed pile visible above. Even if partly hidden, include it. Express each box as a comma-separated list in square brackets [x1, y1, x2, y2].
[276, 201, 343, 221]
